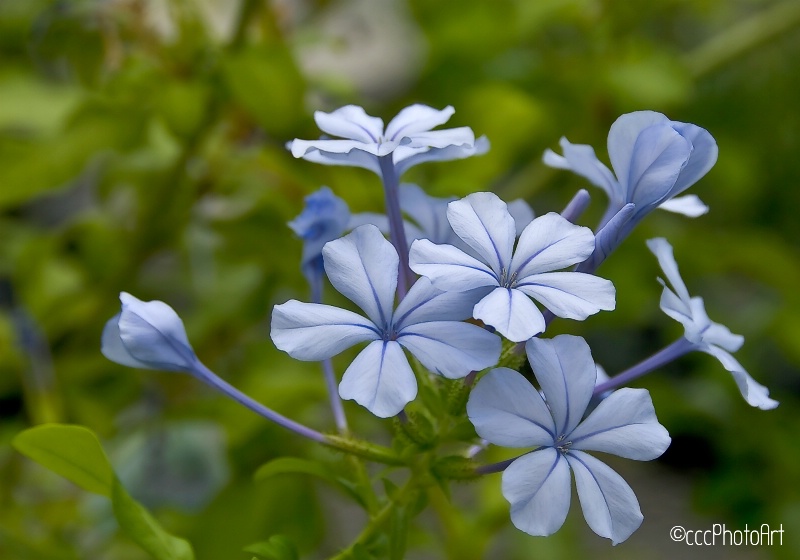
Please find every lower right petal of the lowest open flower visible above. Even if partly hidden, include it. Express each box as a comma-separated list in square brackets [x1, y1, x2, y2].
[567, 451, 644, 544]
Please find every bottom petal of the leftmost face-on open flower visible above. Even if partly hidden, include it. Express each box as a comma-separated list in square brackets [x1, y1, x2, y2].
[339, 340, 417, 418]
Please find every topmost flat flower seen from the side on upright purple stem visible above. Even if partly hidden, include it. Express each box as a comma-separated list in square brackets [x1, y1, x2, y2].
[287, 104, 489, 177]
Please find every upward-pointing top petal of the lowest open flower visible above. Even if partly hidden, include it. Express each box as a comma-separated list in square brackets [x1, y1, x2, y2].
[525, 334, 597, 437]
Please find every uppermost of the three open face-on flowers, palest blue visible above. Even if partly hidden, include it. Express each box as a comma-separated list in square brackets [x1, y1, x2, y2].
[410, 193, 615, 342]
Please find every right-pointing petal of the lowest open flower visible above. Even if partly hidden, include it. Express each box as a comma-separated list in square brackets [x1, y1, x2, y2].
[569, 387, 671, 461]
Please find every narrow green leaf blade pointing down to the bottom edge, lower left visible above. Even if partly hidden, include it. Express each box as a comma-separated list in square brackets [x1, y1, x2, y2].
[111, 479, 194, 560]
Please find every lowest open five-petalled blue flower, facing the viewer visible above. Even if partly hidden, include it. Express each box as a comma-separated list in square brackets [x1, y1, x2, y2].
[467, 335, 670, 544]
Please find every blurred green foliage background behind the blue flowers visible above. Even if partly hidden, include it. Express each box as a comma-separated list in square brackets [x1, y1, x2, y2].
[0, 0, 800, 560]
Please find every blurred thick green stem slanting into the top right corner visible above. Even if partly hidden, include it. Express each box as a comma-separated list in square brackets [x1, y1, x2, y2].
[684, 0, 800, 78]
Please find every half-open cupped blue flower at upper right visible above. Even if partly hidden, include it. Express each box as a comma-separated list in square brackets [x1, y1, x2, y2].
[544, 111, 718, 230]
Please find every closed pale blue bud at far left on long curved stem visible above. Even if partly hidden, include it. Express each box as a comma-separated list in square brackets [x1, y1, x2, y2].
[100, 292, 202, 374]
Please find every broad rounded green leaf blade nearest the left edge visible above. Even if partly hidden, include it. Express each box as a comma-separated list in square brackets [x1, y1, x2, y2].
[12, 424, 114, 497]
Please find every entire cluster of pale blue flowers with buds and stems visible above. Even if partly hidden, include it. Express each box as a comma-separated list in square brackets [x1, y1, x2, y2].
[102, 101, 778, 544]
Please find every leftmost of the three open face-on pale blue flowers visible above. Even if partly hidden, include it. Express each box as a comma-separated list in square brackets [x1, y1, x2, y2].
[270, 225, 501, 418]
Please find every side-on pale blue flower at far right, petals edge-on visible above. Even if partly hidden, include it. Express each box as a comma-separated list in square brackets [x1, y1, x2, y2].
[647, 237, 778, 410]
